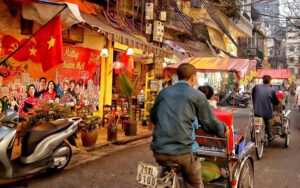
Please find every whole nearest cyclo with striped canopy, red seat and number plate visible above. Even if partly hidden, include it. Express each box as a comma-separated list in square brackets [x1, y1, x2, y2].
[137, 58, 255, 188]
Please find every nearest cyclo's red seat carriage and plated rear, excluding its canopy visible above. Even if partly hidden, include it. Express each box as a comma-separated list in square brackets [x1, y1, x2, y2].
[137, 110, 254, 188]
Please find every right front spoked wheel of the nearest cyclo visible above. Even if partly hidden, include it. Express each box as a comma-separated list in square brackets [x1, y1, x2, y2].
[237, 158, 254, 188]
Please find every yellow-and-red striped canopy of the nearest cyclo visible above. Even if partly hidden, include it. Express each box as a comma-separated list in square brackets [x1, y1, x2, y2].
[166, 57, 254, 79]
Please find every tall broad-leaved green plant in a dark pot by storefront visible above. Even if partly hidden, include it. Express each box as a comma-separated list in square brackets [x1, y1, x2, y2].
[119, 74, 139, 136]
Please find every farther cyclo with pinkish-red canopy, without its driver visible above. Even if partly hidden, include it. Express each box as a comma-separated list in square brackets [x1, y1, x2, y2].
[250, 69, 291, 159]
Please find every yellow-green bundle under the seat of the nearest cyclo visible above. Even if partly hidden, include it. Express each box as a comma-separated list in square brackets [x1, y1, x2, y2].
[200, 160, 222, 182]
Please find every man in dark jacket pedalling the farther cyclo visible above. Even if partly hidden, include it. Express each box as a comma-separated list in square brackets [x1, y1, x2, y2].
[252, 75, 280, 140]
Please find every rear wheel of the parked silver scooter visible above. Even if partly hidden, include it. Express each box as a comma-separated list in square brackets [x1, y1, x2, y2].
[49, 142, 72, 172]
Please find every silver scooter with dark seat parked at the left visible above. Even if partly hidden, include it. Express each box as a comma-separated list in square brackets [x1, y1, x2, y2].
[0, 110, 82, 179]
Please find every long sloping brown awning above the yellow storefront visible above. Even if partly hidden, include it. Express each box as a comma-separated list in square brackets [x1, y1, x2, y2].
[81, 12, 172, 57]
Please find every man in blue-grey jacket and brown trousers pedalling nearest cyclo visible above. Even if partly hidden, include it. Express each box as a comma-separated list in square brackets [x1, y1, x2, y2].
[150, 63, 226, 188]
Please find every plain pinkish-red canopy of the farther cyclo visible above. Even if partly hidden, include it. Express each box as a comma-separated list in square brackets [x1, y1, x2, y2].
[256, 69, 291, 80]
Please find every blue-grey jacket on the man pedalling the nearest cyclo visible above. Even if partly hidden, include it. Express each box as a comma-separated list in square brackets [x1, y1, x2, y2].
[151, 81, 226, 155]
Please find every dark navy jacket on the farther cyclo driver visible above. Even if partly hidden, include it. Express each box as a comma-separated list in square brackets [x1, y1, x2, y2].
[252, 84, 279, 118]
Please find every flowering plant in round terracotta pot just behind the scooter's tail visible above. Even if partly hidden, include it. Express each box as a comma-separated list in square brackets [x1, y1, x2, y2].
[78, 105, 102, 147]
